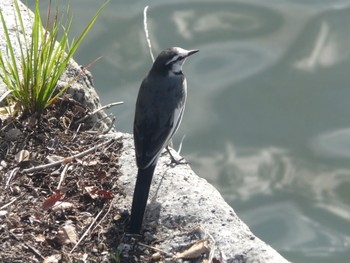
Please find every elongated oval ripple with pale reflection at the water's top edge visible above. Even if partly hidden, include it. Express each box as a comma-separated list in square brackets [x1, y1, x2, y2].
[150, 2, 283, 44]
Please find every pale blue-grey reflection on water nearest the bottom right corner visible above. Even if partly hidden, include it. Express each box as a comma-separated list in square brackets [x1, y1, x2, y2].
[241, 201, 350, 258]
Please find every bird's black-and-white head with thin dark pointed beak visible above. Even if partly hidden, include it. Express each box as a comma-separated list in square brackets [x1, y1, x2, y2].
[152, 47, 199, 75]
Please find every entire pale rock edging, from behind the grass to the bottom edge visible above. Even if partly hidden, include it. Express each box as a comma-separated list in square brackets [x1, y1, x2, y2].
[0, 0, 287, 263]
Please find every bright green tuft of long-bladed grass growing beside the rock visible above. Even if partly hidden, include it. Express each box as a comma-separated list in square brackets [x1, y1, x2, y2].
[0, 0, 109, 114]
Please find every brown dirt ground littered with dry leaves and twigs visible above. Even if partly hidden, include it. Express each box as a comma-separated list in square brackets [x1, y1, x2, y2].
[0, 98, 149, 262]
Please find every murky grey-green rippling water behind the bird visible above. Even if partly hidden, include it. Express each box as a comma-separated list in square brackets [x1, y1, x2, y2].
[30, 0, 350, 263]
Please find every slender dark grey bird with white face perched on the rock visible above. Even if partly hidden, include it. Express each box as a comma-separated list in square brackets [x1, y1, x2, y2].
[129, 47, 199, 234]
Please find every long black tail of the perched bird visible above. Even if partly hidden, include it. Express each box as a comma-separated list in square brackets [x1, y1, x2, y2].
[130, 164, 156, 234]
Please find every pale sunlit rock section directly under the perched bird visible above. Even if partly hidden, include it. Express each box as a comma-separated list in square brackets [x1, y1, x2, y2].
[119, 134, 288, 263]
